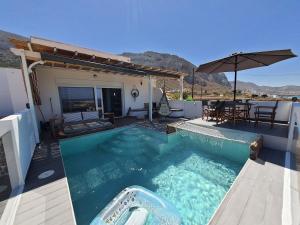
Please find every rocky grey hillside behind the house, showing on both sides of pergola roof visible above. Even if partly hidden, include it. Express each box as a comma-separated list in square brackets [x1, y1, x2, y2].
[0, 30, 231, 93]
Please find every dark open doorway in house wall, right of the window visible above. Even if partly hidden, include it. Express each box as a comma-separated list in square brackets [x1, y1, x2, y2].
[102, 88, 122, 116]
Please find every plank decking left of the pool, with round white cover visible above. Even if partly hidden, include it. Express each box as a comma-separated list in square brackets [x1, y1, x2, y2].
[14, 132, 76, 225]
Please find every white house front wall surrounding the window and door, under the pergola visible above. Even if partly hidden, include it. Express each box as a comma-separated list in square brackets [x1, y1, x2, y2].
[36, 67, 155, 120]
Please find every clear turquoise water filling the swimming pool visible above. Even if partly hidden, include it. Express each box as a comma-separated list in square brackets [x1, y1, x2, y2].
[60, 126, 249, 225]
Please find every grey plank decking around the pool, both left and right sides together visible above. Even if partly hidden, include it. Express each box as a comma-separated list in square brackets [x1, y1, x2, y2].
[9, 121, 300, 225]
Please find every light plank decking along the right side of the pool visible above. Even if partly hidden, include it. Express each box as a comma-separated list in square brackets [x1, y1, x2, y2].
[209, 149, 300, 225]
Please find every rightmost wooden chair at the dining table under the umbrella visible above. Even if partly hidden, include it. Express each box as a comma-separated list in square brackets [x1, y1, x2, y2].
[254, 100, 278, 128]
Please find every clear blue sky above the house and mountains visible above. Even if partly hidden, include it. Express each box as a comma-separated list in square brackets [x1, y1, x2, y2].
[0, 0, 300, 86]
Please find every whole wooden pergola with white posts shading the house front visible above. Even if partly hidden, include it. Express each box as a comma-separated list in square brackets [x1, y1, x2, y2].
[10, 37, 187, 141]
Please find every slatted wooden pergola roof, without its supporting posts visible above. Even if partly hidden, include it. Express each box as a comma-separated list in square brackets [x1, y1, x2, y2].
[10, 37, 187, 79]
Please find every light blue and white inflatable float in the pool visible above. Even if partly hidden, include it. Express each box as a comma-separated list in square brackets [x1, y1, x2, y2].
[90, 185, 181, 225]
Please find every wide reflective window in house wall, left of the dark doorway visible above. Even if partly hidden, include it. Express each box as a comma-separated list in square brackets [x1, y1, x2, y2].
[58, 87, 96, 113]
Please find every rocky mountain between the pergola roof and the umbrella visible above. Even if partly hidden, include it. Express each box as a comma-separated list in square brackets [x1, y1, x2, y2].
[121, 51, 231, 92]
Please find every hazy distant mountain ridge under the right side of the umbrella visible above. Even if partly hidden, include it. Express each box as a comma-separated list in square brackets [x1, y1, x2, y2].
[230, 81, 300, 95]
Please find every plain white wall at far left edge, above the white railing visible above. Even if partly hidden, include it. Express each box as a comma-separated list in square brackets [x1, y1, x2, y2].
[0, 68, 28, 117]
